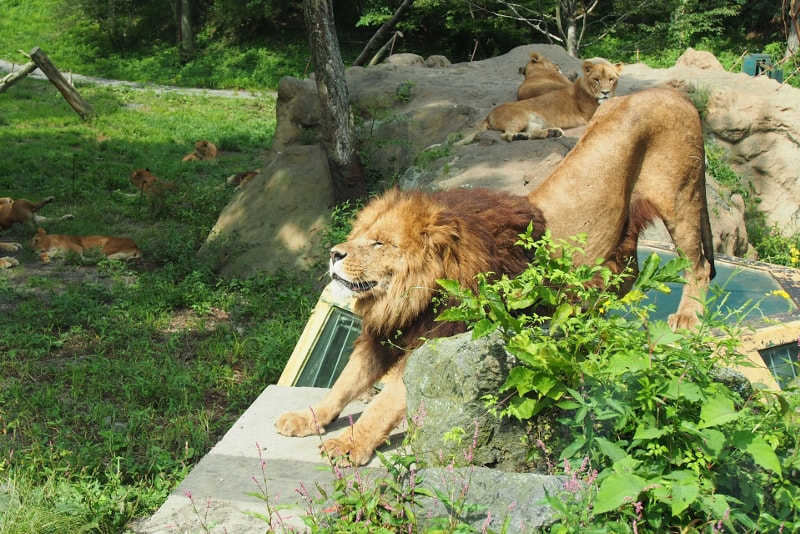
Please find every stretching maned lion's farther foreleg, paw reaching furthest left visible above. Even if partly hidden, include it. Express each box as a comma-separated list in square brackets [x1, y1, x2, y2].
[275, 340, 386, 437]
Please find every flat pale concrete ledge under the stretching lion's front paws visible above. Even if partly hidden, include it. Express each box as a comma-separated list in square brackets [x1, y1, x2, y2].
[132, 385, 404, 534]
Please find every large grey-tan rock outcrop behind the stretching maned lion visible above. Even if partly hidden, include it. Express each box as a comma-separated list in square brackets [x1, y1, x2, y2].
[206, 45, 800, 276]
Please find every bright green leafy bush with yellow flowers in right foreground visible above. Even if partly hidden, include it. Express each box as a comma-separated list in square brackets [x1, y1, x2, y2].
[441, 235, 800, 532]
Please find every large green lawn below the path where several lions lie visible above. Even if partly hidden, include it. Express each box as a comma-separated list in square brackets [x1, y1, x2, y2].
[0, 79, 322, 533]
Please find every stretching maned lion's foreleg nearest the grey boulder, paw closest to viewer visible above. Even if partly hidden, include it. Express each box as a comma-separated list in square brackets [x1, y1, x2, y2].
[322, 365, 406, 465]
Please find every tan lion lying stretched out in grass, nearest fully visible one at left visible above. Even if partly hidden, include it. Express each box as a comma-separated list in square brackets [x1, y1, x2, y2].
[31, 228, 142, 263]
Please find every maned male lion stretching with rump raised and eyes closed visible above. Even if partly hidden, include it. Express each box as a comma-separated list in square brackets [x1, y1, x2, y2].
[275, 89, 714, 464]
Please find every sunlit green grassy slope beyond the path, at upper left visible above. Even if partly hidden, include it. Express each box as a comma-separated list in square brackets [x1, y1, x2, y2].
[0, 0, 310, 91]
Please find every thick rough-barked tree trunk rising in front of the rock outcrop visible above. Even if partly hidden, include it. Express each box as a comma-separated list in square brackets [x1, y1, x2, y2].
[303, 0, 367, 203]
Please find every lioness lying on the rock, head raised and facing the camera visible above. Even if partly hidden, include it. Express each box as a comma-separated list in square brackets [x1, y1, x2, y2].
[456, 60, 622, 146]
